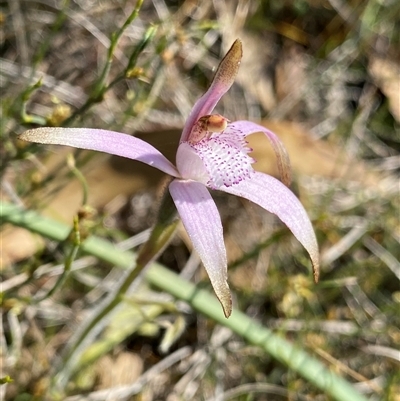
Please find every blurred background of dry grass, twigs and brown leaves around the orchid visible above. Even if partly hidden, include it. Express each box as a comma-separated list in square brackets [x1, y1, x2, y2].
[0, 0, 400, 401]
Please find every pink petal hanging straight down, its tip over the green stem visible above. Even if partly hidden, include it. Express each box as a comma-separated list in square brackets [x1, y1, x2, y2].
[169, 180, 232, 317]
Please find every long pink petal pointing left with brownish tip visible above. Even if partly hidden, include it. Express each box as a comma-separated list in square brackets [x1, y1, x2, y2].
[19, 127, 179, 177]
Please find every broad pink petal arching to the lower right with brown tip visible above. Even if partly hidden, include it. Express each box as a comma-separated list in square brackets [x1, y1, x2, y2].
[219, 172, 319, 282]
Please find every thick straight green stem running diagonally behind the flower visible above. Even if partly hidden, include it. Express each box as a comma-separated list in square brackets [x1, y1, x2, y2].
[0, 202, 367, 401]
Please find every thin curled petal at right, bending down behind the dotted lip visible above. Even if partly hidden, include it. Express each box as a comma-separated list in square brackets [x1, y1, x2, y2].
[228, 121, 292, 186]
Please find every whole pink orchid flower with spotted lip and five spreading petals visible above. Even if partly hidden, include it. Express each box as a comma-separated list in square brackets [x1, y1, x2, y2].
[19, 40, 319, 317]
